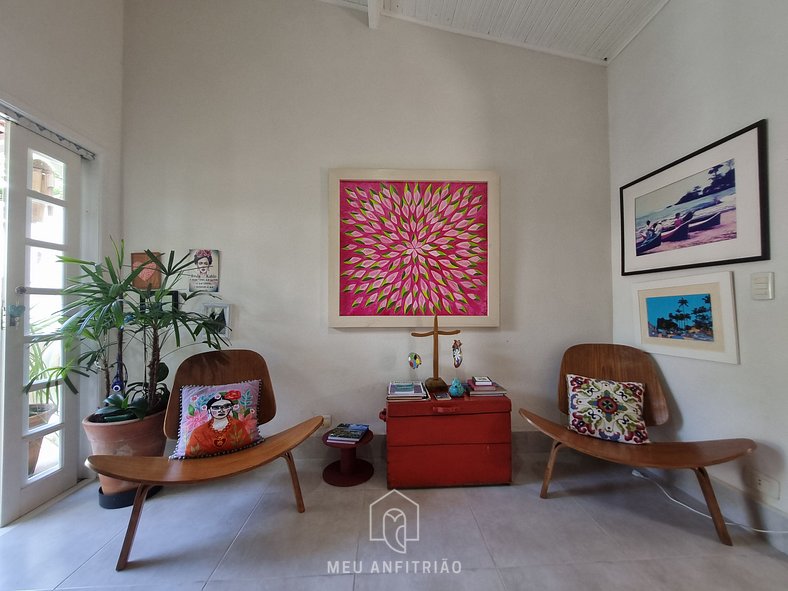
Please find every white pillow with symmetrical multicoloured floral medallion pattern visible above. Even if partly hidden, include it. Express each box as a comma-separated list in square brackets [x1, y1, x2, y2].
[566, 374, 649, 443]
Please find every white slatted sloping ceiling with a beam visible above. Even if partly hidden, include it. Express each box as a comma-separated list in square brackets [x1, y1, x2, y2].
[322, 0, 669, 63]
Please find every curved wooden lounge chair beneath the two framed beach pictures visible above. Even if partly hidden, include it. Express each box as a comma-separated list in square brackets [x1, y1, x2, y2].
[520, 344, 755, 546]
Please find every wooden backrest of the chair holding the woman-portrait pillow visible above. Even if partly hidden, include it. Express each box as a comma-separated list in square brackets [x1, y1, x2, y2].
[164, 349, 276, 439]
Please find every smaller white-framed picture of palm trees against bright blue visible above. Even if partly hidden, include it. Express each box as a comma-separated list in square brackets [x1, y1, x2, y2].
[633, 271, 739, 363]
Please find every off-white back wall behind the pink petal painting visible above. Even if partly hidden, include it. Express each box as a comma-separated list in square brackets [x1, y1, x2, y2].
[123, 0, 612, 430]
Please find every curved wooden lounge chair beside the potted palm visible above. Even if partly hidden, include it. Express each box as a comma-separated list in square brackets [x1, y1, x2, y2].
[85, 350, 323, 570]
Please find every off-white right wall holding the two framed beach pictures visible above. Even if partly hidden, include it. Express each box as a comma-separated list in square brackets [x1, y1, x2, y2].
[608, 0, 788, 512]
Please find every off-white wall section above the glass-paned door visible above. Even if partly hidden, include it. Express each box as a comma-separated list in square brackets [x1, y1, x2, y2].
[0, 0, 123, 248]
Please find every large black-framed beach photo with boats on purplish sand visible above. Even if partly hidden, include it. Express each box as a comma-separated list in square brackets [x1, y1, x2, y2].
[620, 120, 769, 275]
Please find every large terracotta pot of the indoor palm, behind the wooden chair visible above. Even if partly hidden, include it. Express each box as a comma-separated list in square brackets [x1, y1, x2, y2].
[82, 411, 167, 495]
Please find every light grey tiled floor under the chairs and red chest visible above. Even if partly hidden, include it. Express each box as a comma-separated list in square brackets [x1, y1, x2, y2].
[0, 452, 788, 591]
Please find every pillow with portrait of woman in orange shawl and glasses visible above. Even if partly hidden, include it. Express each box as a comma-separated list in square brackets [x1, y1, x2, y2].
[170, 380, 262, 459]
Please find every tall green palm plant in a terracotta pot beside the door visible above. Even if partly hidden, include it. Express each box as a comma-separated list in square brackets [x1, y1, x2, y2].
[29, 242, 227, 507]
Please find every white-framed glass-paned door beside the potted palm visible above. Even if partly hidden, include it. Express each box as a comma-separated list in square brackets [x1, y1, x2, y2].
[0, 120, 81, 525]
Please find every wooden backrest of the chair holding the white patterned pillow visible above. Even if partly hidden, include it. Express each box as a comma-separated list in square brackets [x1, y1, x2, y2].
[558, 343, 668, 425]
